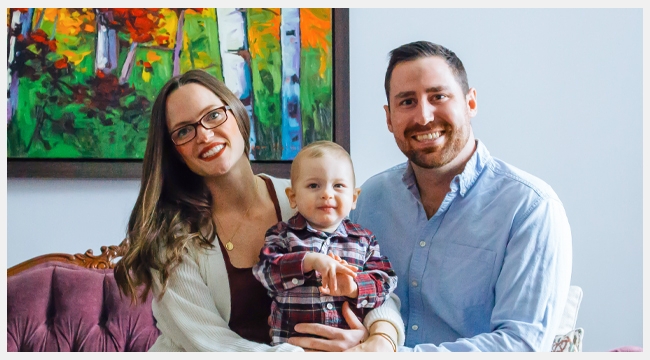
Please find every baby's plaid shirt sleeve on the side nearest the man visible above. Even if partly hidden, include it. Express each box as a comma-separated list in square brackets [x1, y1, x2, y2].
[352, 235, 397, 308]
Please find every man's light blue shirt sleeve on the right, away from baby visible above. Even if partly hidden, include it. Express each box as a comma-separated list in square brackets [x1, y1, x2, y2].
[400, 199, 572, 352]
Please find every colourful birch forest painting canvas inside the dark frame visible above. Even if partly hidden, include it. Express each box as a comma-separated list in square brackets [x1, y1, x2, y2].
[7, 8, 335, 168]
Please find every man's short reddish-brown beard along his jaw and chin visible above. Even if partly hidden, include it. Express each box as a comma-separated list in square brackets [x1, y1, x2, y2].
[399, 123, 469, 169]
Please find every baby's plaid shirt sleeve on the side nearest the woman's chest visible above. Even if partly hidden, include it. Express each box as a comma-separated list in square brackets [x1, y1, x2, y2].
[253, 223, 307, 294]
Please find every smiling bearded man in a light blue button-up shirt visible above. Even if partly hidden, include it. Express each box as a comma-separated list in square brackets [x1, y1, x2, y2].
[351, 41, 571, 351]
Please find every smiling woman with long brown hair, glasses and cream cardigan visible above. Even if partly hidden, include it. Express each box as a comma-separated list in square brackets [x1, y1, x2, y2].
[115, 70, 403, 351]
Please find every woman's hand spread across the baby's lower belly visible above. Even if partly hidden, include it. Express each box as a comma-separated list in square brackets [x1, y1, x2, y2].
[289, 301, 368, 351]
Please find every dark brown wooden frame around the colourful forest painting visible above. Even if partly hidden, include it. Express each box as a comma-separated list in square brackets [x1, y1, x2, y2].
[7, 8, 350, 179]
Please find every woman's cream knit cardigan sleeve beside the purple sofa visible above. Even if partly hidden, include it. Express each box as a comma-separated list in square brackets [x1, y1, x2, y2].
[152, 246, 302, 352]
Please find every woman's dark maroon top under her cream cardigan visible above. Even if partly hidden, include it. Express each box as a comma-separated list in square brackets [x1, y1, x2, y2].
[219, 176, 282, 344]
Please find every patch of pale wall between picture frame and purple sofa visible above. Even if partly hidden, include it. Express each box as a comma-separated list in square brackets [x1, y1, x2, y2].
[7, 179, 140, 267]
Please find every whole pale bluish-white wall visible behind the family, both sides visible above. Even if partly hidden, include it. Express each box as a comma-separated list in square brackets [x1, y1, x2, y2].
[7, 9, 643, 351]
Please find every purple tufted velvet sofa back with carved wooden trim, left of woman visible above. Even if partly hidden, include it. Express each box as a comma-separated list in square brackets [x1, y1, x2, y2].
[7, 243, 160, 352]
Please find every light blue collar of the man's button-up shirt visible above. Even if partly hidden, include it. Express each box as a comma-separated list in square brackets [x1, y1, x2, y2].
[402, 139, 491, 199]
